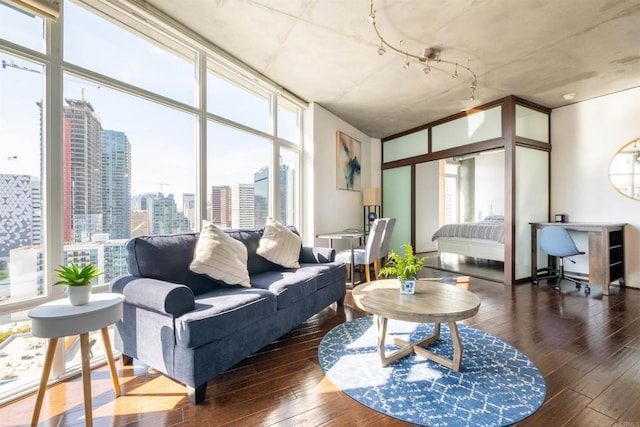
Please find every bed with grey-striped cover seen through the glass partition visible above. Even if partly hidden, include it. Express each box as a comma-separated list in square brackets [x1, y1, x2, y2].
[431, 215, 504, 262]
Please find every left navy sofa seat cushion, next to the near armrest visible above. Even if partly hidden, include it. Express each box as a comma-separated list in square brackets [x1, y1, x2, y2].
[175, 286, 276, 348]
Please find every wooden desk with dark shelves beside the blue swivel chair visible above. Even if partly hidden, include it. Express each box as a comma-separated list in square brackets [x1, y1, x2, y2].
[531, 222, 626, 295]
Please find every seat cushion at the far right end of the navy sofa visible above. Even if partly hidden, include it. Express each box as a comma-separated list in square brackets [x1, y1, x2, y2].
[251, 270, 316, 310]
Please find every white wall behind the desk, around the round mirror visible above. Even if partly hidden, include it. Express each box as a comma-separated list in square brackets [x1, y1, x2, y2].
[551, 88, 640, 288]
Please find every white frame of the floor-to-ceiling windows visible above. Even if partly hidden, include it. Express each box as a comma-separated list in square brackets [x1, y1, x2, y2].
[0, 0, 307, 402]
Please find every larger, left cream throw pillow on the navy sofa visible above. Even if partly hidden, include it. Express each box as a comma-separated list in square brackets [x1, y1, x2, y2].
[189, 220, 251, 288]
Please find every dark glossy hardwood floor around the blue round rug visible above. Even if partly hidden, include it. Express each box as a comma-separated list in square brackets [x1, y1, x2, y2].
[0, 269, 640, 427]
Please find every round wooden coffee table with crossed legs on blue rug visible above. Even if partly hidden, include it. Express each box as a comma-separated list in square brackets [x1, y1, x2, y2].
[353, 279, 480, 371]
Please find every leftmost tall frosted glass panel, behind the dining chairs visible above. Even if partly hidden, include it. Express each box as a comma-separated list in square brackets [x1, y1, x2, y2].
[382, 166, 412, 253]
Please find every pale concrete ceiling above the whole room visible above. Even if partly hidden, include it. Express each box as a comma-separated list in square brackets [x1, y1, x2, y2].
[147, 0, 640, 137]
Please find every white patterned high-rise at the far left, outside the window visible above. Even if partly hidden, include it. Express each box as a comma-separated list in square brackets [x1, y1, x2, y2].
[0, 174, 42, 257]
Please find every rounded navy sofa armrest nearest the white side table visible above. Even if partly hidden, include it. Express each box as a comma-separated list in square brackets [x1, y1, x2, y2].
[111, 275, 195, 317]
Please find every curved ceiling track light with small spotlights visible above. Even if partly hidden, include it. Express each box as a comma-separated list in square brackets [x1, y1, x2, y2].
[367, 0, 478, 101]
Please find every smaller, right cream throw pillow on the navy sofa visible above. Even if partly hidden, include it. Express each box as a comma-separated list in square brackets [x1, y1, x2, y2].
[256, 217, 302, 268]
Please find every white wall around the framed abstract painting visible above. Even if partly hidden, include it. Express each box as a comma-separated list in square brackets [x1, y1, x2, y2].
[302, 104, 381, 249]
